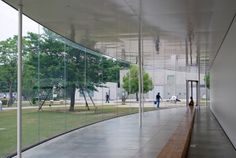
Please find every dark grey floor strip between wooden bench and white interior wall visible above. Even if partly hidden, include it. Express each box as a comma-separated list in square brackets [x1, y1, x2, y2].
[188, 107, 236, 158]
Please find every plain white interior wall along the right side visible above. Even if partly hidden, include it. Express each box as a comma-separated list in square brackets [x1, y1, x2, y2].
[210, 16, 236, 147]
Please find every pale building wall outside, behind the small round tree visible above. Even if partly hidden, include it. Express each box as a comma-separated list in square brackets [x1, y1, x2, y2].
[120, 68, 204, 100]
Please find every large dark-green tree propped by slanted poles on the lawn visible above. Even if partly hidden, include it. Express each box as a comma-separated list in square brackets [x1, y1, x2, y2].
[24, 30, 127, 111]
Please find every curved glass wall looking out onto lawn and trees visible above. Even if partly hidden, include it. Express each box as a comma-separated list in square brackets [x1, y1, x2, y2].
[0, 2, 204, 157]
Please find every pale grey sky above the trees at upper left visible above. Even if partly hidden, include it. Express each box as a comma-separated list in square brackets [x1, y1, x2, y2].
[0, 0, 41, 41]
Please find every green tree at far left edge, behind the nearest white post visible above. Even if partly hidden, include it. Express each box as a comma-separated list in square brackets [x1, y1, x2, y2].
[0, 33, 41, 106]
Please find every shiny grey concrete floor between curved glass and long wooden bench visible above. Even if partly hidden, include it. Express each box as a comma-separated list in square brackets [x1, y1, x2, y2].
[18, 107, 186, 158]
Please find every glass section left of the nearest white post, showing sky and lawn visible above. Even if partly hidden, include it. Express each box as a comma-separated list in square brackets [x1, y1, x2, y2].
[0, 1, 17, 157]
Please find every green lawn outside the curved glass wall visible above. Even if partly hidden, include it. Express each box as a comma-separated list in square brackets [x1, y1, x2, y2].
[0, 105, 155, 157]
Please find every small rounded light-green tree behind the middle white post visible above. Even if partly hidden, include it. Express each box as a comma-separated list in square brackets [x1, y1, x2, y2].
[123, 65, 154, 101]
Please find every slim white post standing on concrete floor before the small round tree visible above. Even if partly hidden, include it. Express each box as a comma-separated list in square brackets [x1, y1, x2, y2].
[138, 0, 143, 128]
